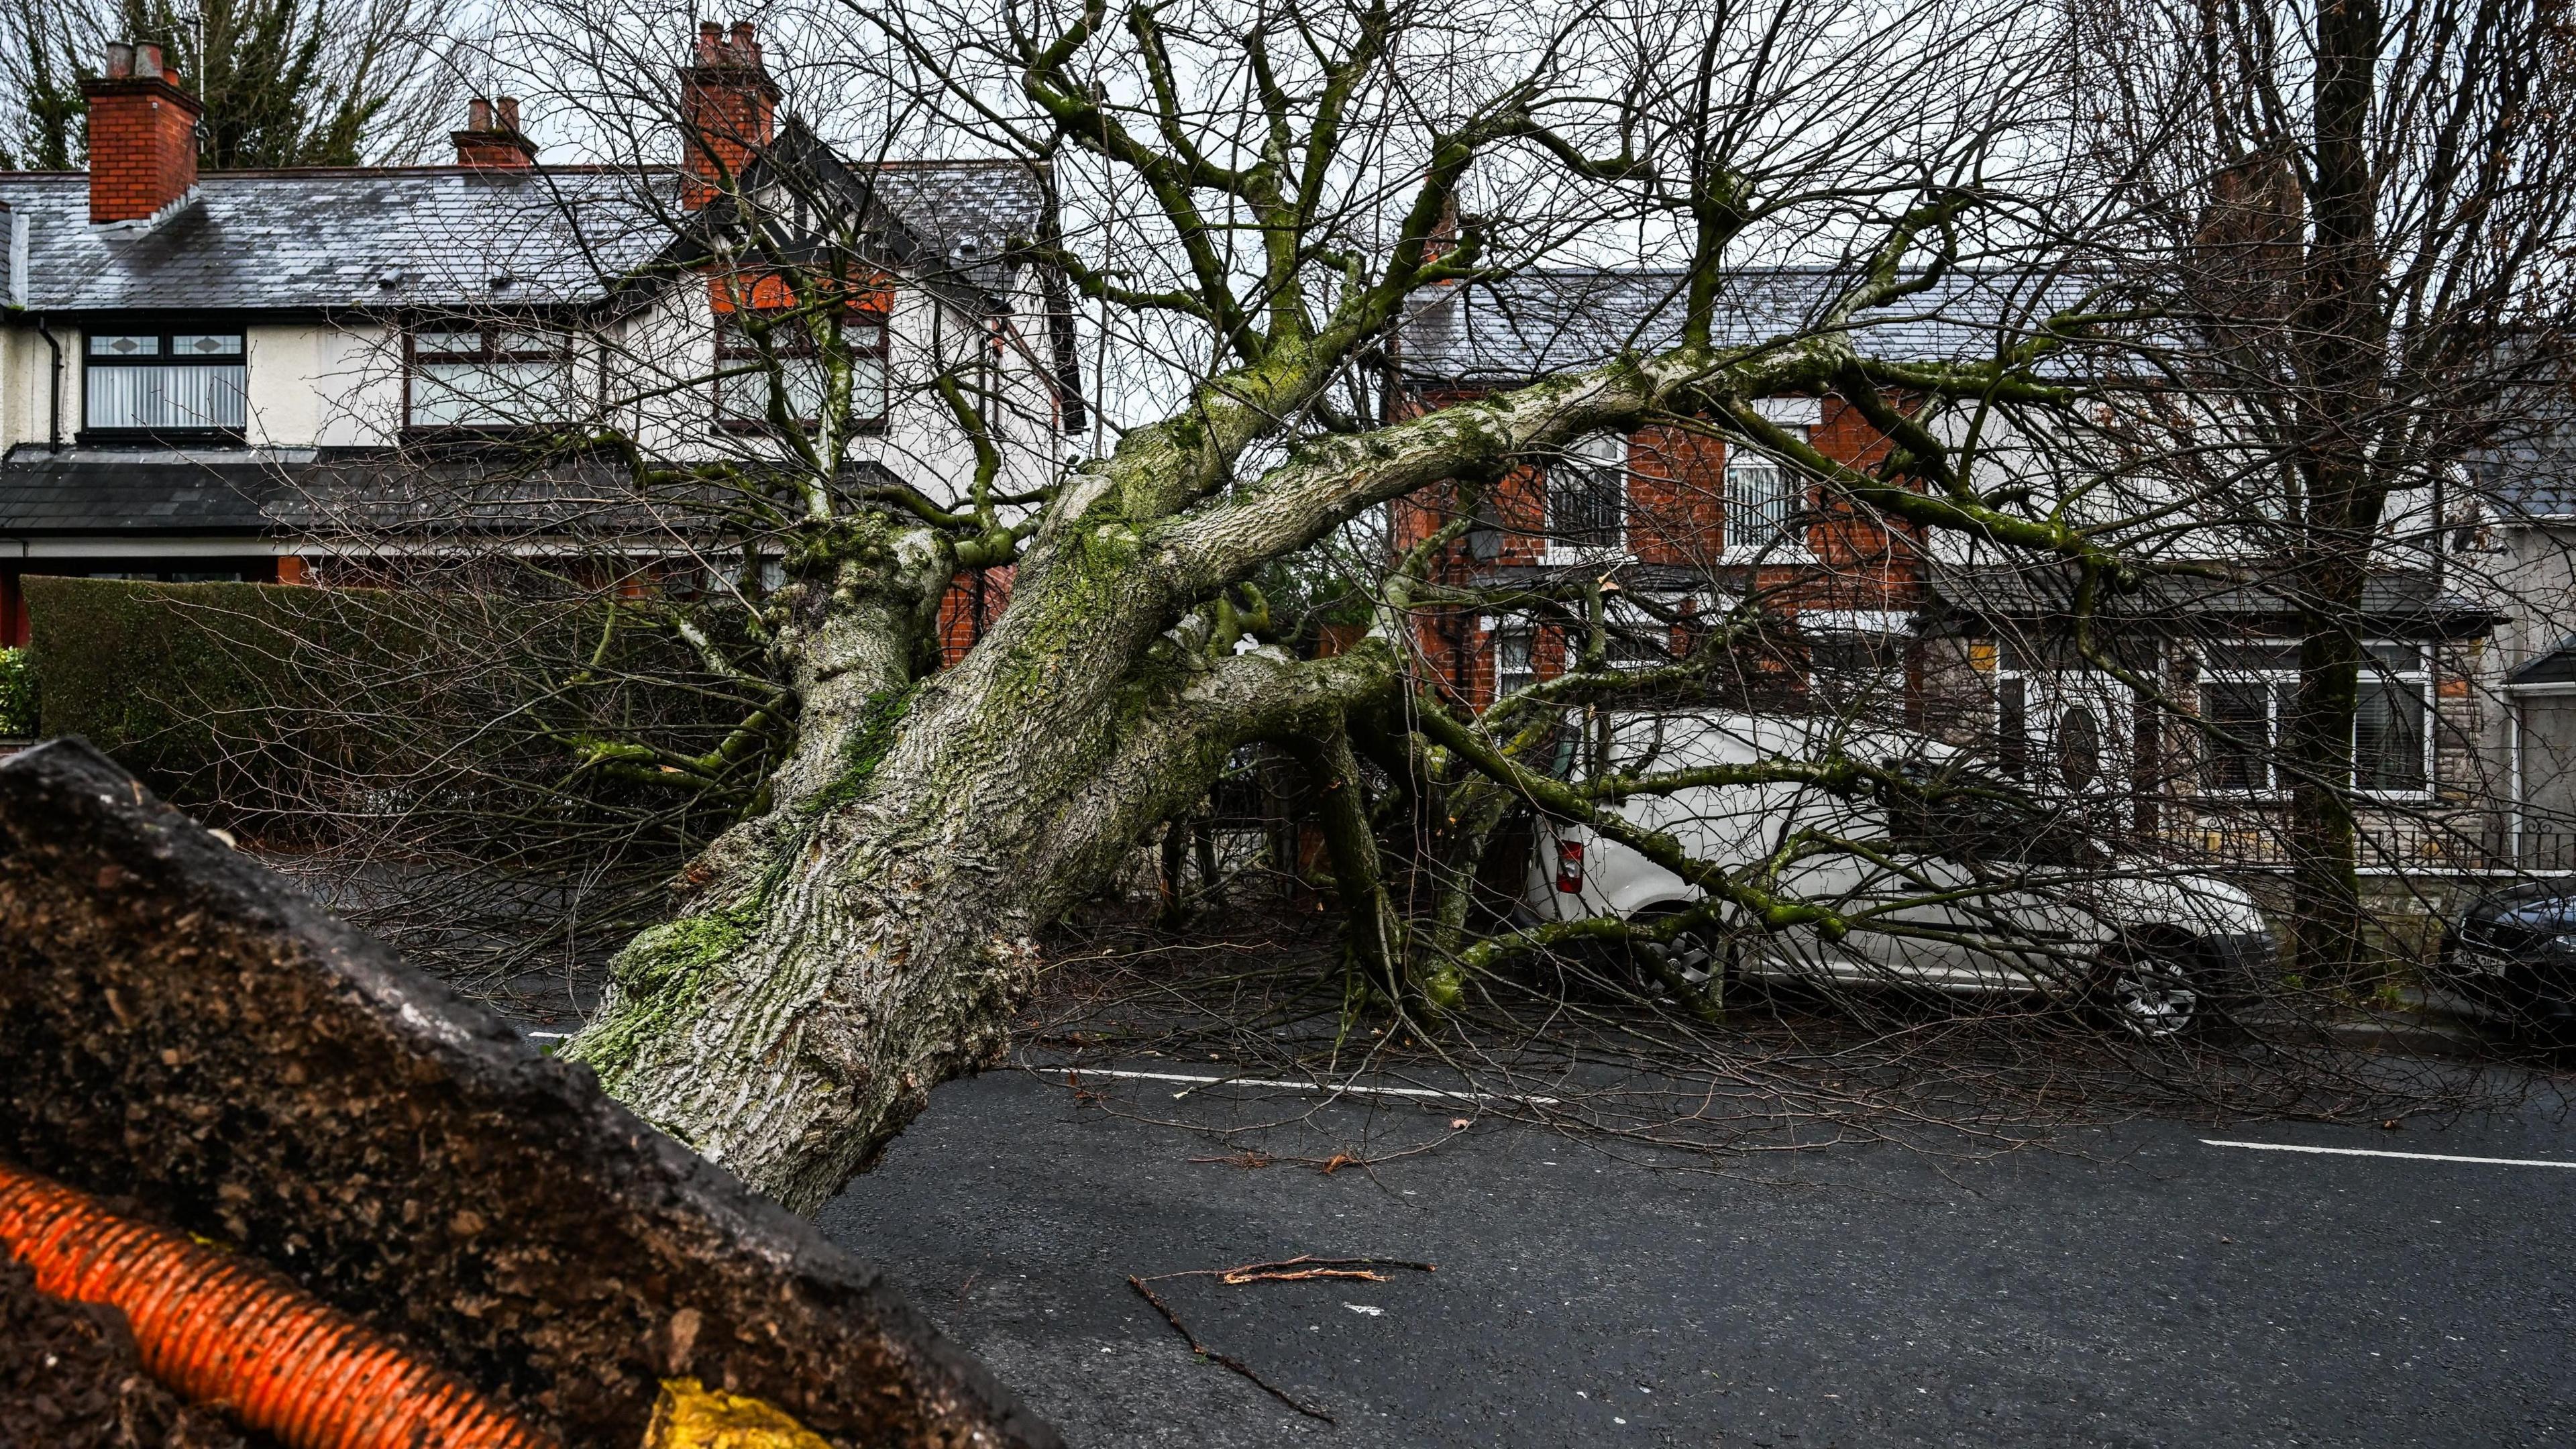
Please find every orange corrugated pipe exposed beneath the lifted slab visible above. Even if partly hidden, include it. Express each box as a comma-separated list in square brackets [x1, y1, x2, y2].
[0, 1163, 554, 1449]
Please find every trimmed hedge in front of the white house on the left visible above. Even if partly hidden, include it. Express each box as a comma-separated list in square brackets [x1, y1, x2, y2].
[22, 578, 749, 841]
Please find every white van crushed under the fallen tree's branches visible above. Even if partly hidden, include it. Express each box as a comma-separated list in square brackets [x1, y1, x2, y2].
[1525, 712, 2275, 1036]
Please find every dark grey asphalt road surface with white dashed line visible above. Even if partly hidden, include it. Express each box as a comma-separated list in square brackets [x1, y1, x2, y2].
[819, 1065, 2576, 1449]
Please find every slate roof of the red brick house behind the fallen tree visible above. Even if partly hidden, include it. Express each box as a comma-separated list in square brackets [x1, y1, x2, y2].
[1399, 268, 2071, 382]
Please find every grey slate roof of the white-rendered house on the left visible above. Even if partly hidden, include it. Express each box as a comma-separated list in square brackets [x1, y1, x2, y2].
[0, 149, 1043, 312]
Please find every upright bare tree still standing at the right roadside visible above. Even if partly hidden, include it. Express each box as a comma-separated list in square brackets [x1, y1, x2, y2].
[2071, 0, 2576, 979]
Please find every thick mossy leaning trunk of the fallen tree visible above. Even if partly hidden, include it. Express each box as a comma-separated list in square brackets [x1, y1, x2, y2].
[570, 494, 1393, 1212]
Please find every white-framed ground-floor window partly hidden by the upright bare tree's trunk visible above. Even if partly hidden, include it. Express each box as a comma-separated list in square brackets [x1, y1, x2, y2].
[2200, 639, 2432, 794]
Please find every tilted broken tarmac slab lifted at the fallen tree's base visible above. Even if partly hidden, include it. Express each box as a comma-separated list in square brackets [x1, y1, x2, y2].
[0, 743, 1061, 1449]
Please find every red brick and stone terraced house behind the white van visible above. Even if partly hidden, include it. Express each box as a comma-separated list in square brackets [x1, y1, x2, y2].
[1391, 268, 2514, 879]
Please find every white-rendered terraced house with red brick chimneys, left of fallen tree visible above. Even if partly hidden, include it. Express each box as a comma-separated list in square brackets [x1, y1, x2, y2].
[0, 23, 1082, 642]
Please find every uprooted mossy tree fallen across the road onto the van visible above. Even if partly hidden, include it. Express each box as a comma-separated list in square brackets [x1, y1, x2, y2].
[479, 3, 2125, 1210]
